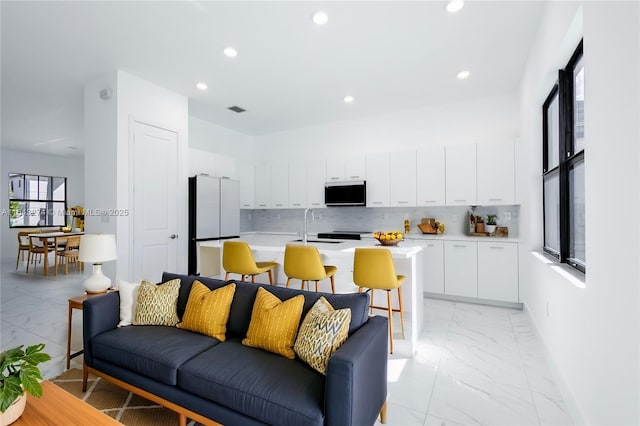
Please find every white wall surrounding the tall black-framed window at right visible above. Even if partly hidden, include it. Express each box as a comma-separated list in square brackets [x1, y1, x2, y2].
[518, 1, 640, 424]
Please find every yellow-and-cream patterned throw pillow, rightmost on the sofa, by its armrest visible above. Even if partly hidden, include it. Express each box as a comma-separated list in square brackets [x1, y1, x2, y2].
[293, 297, 351, 374]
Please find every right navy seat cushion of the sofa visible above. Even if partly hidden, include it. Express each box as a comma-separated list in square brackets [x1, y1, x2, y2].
[178, 339, 325, 426]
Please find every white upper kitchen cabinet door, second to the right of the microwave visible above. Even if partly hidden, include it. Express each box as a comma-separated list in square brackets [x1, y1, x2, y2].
[389, 151, 416, 207]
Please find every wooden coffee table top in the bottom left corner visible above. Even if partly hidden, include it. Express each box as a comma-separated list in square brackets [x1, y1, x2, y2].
[12, 381, 122, 426]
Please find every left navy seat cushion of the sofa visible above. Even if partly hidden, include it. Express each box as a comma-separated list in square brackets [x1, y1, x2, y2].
[91, 326, 219, 385]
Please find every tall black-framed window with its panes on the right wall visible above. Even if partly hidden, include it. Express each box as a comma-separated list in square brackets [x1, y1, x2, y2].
[542, 41, 586, 272]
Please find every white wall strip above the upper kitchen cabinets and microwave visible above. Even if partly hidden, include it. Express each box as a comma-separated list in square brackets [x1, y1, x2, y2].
[254, 93, 518, 161]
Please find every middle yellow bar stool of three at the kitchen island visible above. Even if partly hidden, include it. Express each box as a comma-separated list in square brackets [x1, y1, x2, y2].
[284, 244, 338, 293]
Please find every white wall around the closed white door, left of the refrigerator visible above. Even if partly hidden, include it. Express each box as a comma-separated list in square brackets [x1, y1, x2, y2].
[85, 70, 189, 280]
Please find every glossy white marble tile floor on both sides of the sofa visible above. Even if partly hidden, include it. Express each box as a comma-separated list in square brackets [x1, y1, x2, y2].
[0, 262, 573, 426]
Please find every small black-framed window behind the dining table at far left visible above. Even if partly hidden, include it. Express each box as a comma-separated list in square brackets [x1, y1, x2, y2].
[9, 173, 67, 228]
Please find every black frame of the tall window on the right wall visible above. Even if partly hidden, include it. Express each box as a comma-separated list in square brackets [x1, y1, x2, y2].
[542, 40, 586, 273]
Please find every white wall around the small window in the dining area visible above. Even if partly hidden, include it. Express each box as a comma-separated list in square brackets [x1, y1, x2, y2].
[0, 149, 84, 261]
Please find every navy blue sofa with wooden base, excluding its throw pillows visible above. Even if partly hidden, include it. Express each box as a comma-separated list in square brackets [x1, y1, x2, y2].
[83, 273, 388, 426]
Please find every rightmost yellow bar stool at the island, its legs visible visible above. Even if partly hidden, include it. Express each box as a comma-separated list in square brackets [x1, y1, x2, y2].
[353, 248, 406, 353]
